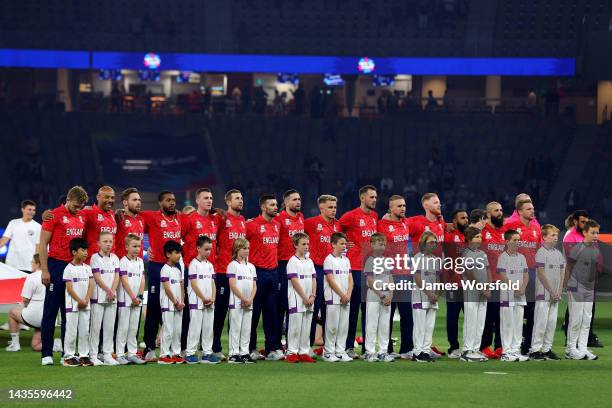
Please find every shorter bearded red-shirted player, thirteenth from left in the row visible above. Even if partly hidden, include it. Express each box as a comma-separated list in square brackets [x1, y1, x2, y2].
[444, 209, 469, 358]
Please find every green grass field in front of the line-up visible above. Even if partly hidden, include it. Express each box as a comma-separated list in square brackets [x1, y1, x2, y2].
[0, 302, 612, 407]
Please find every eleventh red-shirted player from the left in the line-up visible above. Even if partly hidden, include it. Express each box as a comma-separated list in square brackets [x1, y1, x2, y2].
[376, 195, 414, 360]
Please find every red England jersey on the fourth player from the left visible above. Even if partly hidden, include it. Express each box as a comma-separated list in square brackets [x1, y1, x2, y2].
[140, 210, 181, 263]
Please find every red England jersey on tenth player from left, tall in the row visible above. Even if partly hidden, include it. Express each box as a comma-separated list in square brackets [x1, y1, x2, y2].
[338, 207, 378, 271]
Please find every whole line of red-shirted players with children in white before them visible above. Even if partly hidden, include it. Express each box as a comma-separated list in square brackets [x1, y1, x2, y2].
[19, 186, 600, 365]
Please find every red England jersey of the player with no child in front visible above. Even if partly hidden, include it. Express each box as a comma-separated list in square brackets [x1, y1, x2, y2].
[246, 215, 280, 269]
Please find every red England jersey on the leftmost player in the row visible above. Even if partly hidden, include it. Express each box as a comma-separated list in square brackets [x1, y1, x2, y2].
[42, 205, 85, 262]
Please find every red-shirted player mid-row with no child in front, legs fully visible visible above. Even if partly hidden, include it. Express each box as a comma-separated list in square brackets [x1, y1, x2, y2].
[246, 195, 285, 360]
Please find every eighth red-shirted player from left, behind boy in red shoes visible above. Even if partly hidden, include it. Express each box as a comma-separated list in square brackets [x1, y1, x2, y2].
[276, 189, 304, 352]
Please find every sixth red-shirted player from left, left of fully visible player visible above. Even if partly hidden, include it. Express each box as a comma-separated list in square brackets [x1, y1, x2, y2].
[213, 189, 246, 360]
